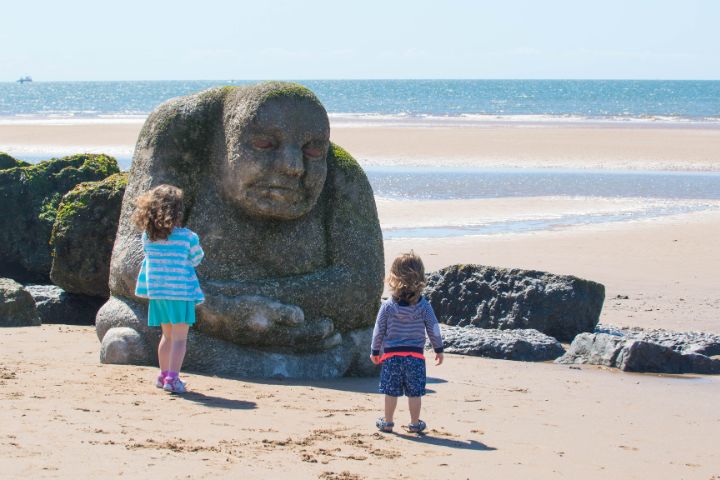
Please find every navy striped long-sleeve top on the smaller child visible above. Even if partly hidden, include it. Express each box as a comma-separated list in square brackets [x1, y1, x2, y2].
[371, 297, 443, 355]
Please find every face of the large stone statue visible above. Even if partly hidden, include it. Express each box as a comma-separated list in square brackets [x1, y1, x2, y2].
[221, 97, 330, 219]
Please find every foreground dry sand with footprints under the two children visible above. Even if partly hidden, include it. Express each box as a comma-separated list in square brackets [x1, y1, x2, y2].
[0, 325, 720, 480]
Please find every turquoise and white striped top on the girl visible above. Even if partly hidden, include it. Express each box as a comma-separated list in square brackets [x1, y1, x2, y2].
[135, 227, 205, 303]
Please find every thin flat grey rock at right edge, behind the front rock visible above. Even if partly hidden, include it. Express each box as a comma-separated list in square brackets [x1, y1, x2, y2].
[595, 323, 720, 357]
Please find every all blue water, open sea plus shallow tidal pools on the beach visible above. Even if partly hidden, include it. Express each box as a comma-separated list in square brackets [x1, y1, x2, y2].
[0, 79, 720, 238]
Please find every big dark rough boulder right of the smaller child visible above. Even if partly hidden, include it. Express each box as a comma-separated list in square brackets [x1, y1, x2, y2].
[424, 265, 605, 341]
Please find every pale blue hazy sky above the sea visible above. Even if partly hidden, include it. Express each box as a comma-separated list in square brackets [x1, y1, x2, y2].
[0, 0, 720, 81]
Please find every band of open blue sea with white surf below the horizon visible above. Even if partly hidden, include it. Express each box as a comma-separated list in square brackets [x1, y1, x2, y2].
[0, 80, 720, 126]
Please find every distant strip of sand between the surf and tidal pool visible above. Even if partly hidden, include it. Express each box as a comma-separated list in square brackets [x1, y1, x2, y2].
[0, 120, 720, 171]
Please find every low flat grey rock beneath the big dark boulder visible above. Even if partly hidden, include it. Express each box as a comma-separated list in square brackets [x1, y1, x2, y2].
[440, 325, 565, 362]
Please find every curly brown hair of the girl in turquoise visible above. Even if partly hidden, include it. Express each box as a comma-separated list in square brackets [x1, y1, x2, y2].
[133, 185, 184, 242]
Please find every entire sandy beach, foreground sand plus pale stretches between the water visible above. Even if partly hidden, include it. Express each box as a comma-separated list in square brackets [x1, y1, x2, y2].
[0, 122, 720, 480]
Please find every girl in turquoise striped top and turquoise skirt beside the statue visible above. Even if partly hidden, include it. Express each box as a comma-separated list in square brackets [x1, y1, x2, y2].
[133, 185, 204, 393]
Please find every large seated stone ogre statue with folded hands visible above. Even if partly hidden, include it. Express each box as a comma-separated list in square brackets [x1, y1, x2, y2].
[96, 82, 384, 378]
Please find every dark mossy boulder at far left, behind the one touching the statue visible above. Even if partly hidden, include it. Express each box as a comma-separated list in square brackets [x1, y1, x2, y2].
[0, 154, 118, 283]
